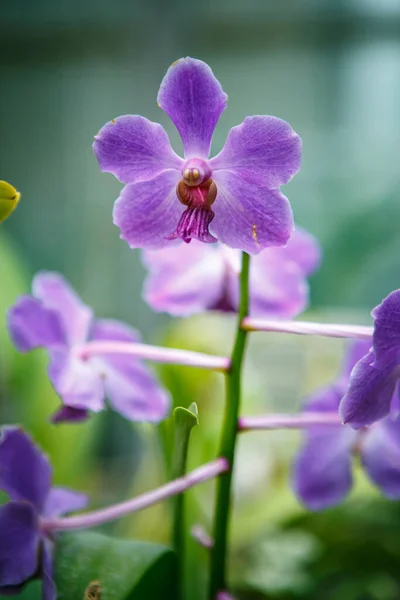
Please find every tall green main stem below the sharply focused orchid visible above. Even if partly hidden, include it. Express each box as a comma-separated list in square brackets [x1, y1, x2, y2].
[209, 252, 250, 600]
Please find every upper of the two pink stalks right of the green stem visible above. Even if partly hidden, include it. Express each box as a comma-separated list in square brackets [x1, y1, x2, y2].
[242, 317, 374, 340]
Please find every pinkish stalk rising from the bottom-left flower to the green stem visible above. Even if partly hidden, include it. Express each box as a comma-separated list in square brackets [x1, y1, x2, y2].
[41, 458, 230, 532]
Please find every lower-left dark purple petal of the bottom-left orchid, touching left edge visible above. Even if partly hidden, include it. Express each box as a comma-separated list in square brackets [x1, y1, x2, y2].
[0, 502, 39, 588]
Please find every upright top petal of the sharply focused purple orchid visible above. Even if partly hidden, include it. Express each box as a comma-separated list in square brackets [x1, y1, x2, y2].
[157, 57, 228, 158]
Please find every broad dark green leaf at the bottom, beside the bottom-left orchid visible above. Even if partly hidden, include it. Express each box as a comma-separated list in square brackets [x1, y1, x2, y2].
[55, 532, 176, 600]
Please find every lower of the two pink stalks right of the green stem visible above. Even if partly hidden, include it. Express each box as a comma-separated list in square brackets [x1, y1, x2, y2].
[238, 412, 342, 431]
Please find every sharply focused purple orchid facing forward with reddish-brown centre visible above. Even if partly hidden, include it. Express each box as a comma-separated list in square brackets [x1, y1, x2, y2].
[93, 58, 301, 254]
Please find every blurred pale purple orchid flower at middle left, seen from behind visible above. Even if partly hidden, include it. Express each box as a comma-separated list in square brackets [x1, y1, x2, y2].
[8, 273, 170, 422]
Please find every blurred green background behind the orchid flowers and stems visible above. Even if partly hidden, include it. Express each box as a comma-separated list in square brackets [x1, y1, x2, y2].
[0, 0, 400, 600]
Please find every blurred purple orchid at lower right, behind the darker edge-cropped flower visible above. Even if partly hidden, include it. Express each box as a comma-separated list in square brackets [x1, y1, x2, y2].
[293, 341, 400, 510]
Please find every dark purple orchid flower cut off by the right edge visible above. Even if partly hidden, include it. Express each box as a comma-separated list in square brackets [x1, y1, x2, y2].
[339, 290, 400, 429]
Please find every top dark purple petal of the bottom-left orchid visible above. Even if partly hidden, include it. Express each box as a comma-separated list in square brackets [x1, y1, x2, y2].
[0, 427, 51, 510]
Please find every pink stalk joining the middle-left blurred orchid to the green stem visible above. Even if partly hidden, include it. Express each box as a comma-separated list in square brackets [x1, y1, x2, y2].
[75, 340, 230, 371]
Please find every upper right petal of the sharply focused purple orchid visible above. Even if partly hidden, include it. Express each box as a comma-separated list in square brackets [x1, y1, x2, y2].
[209, 116, 301, 189]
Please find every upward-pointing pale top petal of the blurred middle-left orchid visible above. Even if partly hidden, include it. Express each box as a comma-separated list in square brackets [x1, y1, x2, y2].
[32, 272, 93, 344]
